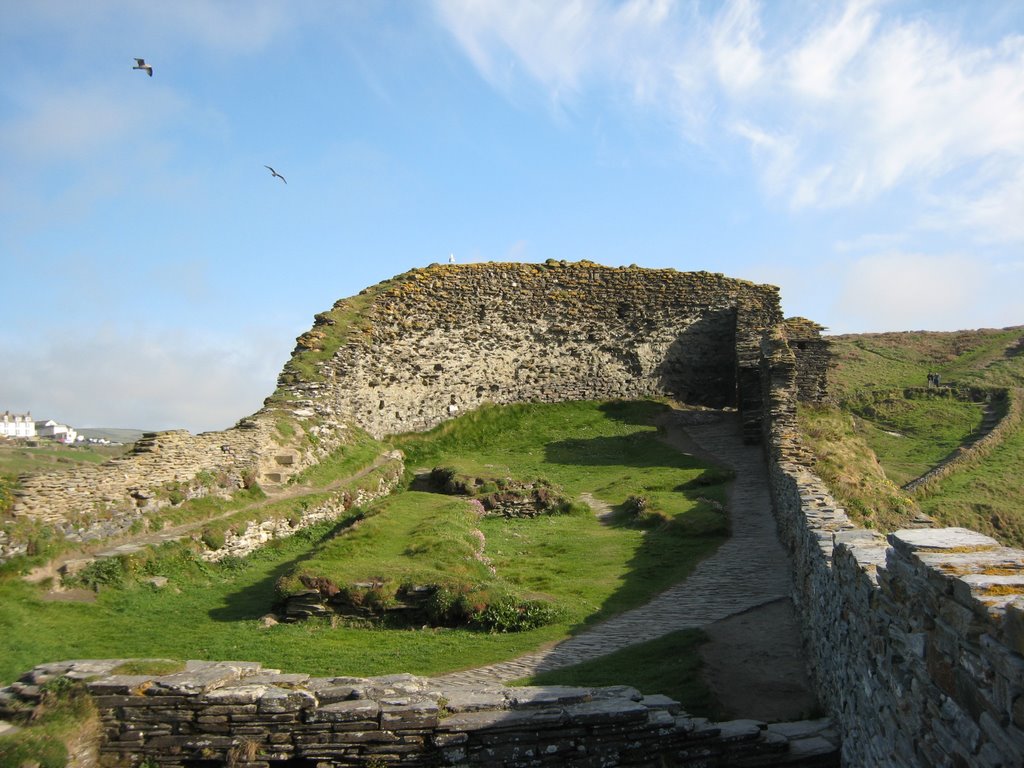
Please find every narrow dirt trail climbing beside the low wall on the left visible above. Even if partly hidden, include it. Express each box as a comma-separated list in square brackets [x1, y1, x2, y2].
[25, 452, 399, 589]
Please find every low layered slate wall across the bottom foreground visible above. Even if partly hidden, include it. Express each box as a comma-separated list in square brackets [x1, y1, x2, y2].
[0, 660, 838, 768]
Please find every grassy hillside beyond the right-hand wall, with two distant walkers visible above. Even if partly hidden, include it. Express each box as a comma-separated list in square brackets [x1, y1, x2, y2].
[800, 328, 1024, 546]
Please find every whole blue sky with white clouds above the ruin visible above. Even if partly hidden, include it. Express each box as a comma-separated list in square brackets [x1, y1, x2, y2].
[0, 0, 1024, 431]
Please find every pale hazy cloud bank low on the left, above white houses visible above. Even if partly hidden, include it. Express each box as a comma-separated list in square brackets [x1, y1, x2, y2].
[0, 329, 292, 432]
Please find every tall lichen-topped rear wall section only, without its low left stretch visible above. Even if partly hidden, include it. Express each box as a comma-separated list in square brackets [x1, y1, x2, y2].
[279, 262, 781, 436]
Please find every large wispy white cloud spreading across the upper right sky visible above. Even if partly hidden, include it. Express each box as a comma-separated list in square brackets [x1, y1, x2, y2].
[438, 0, 1024, 240]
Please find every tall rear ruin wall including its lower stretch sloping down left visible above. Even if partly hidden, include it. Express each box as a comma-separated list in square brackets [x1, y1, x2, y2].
[6, 262, 781, 560]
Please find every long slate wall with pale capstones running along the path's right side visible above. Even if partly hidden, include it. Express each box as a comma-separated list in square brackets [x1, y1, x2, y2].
[762, 338, 1024, 768]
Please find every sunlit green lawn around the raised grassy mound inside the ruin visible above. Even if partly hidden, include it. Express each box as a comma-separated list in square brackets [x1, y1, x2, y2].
[0, 403, 728, 700]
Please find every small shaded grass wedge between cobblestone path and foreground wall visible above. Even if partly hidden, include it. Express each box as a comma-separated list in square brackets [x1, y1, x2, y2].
[516, 630, 721, 717]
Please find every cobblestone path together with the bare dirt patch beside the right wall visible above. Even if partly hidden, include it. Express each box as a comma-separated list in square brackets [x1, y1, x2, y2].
[440, 410, 816, 721]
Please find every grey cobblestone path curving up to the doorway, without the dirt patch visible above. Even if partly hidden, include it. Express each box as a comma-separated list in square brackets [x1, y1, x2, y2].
[439, 411, 791, 685]
